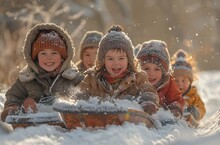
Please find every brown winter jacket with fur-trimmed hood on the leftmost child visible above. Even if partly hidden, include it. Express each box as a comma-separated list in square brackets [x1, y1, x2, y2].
[1, 23, 83, 114]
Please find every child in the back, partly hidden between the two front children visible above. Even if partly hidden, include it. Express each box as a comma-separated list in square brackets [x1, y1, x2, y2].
[77, 31, 103, 72]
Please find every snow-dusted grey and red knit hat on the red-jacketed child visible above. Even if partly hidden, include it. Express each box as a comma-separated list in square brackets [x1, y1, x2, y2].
[137, 40, 170, 75]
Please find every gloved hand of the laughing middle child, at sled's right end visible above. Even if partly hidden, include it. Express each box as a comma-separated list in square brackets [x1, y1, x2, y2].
[141, 101, 159, 115]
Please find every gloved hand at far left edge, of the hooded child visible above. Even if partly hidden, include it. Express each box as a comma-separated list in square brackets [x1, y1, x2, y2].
[1, 104, 21, 122]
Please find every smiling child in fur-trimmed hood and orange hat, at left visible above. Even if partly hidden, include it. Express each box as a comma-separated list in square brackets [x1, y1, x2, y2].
[1, 23, 83, 121]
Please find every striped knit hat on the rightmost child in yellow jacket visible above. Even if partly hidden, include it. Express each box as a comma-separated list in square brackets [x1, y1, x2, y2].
[172, 49, 193, 83]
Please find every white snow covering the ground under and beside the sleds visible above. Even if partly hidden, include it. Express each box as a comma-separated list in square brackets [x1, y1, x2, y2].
[0, 71, 220, 145]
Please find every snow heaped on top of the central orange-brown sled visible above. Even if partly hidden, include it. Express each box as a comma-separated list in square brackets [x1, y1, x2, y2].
[54, 97, 143, 113]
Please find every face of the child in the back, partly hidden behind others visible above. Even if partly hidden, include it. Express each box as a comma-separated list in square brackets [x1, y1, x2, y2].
[82, 48, 97, 69]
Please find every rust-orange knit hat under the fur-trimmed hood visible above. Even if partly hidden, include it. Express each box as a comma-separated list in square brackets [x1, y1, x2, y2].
[31, 31, 67, 60]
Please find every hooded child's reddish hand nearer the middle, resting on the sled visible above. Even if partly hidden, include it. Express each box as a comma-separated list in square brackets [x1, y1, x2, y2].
[23, 98, 37, 113]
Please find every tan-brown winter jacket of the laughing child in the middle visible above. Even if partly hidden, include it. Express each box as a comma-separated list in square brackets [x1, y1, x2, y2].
[80, 70, 159, 106]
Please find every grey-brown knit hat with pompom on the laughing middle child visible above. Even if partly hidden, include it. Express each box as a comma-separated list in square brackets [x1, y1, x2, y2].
[97, 25, 134, 68]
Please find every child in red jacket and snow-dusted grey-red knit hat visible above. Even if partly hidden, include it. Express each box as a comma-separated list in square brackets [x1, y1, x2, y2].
[137, 40, 184, 118]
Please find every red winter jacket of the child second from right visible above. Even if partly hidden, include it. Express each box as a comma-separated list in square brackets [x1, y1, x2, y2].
[157, 75, 184, 112]
